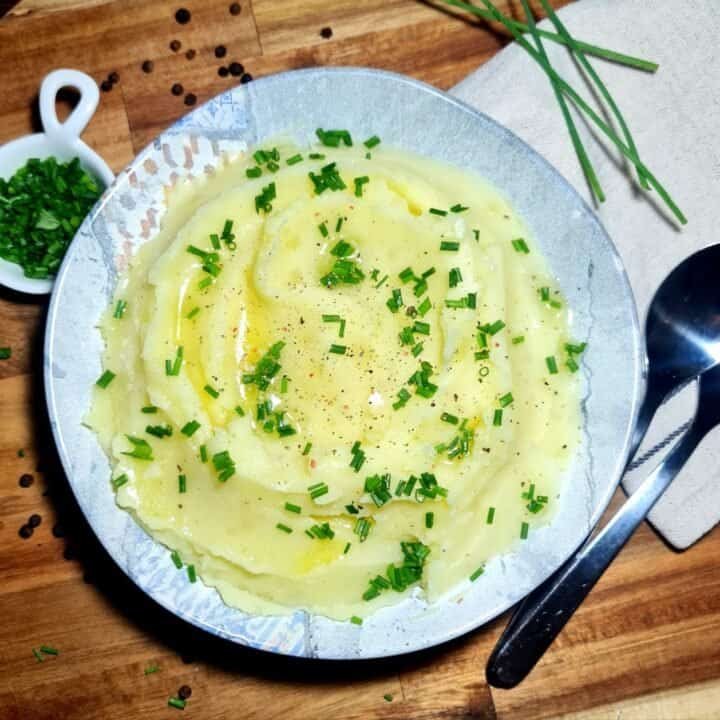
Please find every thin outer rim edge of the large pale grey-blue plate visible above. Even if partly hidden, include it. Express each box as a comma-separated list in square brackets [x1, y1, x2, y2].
[44, 66, 647, 660]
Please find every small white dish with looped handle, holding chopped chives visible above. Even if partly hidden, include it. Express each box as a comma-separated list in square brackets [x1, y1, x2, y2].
[0, 70, 115, 295]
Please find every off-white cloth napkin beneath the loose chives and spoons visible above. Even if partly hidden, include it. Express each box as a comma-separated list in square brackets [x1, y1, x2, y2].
[451, 0, 720, 549]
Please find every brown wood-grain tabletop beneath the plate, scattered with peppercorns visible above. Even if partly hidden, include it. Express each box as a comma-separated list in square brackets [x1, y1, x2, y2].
[0, 0, 720, 720]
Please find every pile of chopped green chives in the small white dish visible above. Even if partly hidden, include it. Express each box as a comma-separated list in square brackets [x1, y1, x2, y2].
[0, 157, 102, 279]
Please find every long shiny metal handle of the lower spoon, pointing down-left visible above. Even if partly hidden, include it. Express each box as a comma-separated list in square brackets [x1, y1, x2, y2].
[486, 422, 709, 688]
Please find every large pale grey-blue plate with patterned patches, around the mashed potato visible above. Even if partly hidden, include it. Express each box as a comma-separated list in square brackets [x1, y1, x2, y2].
[45, 68, 643, 659]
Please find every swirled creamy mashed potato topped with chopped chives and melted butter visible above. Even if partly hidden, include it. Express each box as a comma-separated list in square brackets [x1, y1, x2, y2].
[88, 136, 581, 619]
